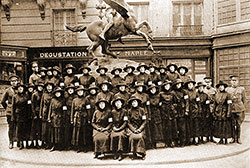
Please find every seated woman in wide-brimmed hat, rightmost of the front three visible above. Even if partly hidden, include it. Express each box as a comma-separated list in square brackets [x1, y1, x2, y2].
[127, 95, 147, 160]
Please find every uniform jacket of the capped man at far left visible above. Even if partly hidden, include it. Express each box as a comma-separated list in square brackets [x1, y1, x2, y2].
[1, 87, 16, 116]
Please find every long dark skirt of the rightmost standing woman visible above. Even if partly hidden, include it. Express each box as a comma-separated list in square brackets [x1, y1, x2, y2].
[214, 118, 232, 138]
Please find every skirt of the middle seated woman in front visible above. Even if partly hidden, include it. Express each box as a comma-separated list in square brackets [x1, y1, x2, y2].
[110, 130, 126, 152]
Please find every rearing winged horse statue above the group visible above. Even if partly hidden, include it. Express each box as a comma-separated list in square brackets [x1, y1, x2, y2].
[66, 0, 154, 62]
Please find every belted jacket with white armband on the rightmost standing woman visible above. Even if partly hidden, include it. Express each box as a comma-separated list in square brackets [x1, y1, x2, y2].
[214, 92, 232, 120]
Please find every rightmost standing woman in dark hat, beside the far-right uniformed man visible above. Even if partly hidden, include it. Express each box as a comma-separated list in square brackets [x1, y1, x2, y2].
[214, 81, 232, 144]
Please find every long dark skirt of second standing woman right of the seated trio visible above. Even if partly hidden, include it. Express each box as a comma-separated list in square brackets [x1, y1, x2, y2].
[163, 119, 178, 143]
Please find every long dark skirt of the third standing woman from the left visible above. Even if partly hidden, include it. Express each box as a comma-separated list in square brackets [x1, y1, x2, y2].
[31, 118, 42, 140]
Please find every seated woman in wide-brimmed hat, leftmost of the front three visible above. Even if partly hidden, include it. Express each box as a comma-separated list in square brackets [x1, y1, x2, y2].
[92, 97, 112, 159]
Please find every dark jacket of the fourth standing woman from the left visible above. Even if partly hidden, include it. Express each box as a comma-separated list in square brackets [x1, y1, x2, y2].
[39, 92, 53, 121]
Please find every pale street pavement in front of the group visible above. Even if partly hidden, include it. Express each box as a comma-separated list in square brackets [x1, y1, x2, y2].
[0, 121, 250, 168]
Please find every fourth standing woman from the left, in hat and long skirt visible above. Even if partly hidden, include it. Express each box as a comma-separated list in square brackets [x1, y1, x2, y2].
[39, 82, 54, 149]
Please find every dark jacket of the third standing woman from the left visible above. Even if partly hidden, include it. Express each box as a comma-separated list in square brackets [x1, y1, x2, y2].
[31, 91, 43, 118]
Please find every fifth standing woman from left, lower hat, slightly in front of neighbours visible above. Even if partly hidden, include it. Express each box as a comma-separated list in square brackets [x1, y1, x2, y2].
[48, 87, 64, 152]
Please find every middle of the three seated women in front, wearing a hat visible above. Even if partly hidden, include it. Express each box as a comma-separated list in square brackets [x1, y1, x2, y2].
[110, 95, 128, 161]
